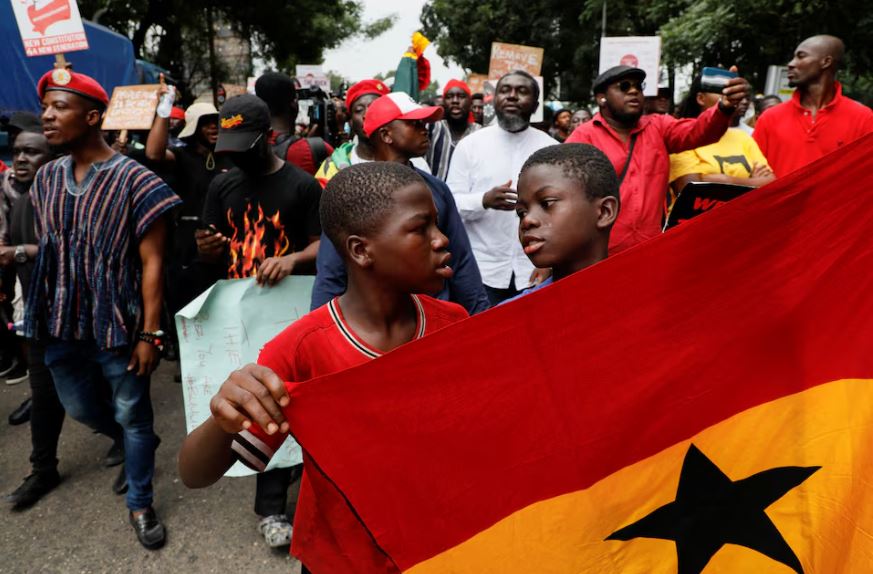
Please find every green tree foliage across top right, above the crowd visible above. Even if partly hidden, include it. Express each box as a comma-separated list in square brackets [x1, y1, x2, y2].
[421, 0, 873, 106]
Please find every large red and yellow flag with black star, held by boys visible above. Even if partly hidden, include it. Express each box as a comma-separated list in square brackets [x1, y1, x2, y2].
[282, 136, 873, 574]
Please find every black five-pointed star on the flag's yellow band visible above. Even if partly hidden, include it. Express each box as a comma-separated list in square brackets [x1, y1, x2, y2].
[606, 444, 821, 574]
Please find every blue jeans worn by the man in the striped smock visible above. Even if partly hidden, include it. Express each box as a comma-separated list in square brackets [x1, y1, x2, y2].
[45, 339, 157, 510]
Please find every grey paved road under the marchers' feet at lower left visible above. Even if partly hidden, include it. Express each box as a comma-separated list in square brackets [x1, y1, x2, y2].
[0, 363, 299, 574]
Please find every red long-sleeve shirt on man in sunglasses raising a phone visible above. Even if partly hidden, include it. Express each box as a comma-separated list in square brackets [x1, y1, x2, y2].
[564, 106, 730, 253]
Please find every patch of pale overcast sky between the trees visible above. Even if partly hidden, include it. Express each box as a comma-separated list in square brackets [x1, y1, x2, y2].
[323, 0, 464, 86]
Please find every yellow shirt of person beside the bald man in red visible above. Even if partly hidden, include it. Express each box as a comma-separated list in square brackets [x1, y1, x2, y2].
[670, 128, 769, 182]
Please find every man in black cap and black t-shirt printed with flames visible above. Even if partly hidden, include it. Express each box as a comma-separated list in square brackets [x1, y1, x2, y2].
[196, 94, 321, 285]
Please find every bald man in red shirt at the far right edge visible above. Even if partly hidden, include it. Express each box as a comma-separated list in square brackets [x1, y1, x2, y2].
[754, 36, 873, 177]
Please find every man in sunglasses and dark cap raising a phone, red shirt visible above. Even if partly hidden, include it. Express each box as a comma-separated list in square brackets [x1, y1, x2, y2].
[565, 66, 749, 254]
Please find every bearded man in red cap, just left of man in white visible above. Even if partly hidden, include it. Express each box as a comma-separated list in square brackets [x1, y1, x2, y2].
[424, 80, 482, 181]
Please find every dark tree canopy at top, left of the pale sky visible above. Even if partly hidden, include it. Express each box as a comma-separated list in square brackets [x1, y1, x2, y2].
[79, 0, 394, 101]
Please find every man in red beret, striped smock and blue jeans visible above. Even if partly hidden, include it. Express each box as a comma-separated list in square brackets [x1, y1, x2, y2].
[24, 69, 180, 549]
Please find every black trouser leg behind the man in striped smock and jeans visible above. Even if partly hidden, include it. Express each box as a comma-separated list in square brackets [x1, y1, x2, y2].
[27, 341, 65, 474]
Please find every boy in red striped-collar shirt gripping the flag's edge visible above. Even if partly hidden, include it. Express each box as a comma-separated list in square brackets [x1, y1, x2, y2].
[179, 162, 467, 572]
